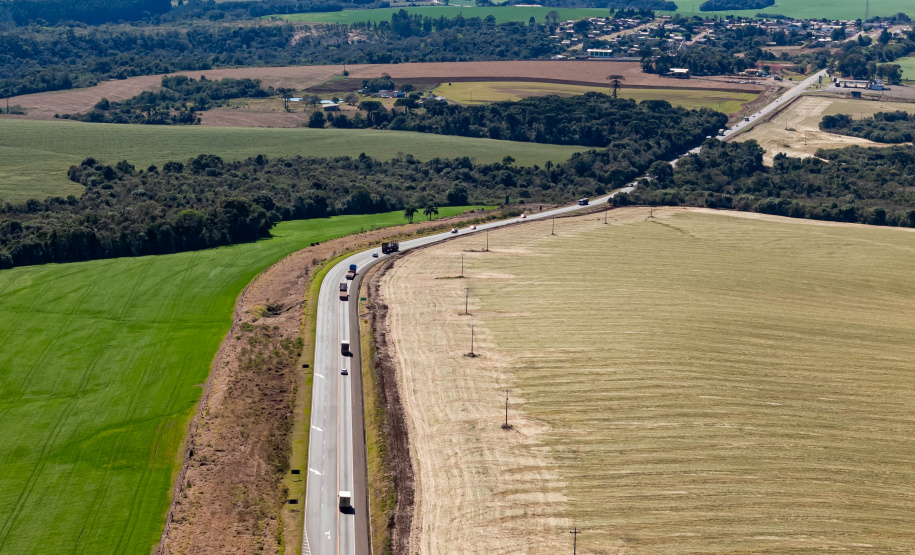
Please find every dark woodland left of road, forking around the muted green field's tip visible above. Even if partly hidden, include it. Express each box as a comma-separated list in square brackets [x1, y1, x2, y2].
[0, 96, 725, 267]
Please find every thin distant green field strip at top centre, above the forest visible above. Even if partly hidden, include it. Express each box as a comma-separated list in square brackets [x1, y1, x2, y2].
[272, 6, 610, 23]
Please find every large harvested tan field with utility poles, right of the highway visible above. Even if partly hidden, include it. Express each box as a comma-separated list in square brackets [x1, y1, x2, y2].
[381, 208, 915, 554]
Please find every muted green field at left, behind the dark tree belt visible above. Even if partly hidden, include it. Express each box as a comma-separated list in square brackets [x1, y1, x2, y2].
[0, 120, 585, 202]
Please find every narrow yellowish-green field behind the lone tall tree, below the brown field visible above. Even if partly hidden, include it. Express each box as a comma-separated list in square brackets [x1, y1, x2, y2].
[433, 81, 758, 113]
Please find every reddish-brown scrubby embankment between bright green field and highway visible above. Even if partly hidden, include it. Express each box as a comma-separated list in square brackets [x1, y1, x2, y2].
[158, 207, 516, 555]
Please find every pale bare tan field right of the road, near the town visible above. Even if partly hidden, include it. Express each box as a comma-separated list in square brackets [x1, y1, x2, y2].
[739, 95, 915, 164]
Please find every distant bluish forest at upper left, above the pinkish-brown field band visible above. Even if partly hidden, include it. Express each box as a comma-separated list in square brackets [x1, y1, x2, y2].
[0, 14, 558, 97]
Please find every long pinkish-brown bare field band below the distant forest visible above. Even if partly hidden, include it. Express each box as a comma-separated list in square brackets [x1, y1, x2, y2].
[10, 61, 763, 123]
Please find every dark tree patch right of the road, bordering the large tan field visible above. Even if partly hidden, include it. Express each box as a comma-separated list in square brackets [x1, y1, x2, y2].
[614, 139, 915, 227]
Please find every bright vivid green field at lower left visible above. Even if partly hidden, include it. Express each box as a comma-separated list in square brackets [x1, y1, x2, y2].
[0, 208, 480, 555]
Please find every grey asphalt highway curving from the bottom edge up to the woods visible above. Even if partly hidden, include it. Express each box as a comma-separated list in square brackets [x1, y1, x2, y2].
[302, 187, 633, 555]
